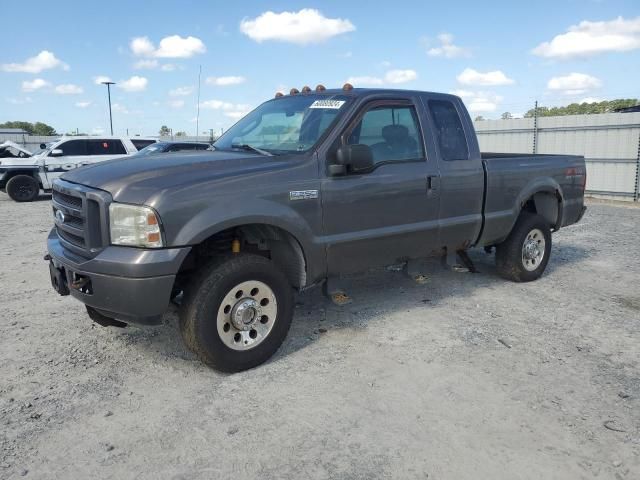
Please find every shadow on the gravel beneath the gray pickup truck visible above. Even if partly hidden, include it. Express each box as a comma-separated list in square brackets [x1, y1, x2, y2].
[120, 245, 588, 372]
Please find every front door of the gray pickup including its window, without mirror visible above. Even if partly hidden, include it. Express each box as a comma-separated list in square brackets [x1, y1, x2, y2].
[322, 99, 439, 275]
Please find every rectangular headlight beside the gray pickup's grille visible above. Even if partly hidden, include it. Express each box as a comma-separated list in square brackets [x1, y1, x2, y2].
[109, 203, 163, 248]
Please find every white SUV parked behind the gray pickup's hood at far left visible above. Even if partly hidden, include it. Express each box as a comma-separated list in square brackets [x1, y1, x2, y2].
[0, 136, 157, 202]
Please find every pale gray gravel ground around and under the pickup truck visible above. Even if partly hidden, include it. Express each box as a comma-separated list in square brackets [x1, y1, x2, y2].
[0, 194, 640, 479]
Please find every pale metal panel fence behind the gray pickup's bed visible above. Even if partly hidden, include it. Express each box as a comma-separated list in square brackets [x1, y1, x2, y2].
[474, 113, 640, 201]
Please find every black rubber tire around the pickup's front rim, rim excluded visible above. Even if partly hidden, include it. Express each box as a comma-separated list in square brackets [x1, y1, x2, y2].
[180, 254, 294, 372]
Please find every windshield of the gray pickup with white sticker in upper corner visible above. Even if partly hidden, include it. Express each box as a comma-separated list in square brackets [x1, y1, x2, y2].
[214, 95, 348, 155]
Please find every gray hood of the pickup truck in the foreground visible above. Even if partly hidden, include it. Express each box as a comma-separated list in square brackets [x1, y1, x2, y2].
[61, 151, 287, 205]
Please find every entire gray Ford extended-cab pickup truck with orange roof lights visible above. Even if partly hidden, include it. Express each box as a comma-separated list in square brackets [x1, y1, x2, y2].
[45, 84, 586, 371]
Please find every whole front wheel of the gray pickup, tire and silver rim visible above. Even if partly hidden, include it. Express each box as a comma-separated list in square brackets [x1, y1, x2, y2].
[180, 254, 293, 372]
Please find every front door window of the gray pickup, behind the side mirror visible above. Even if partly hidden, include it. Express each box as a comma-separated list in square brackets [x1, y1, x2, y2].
[347, 105, 424, 163]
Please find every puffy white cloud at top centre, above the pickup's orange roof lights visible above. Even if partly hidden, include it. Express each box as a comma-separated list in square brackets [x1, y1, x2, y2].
[240, 8, 356, 45]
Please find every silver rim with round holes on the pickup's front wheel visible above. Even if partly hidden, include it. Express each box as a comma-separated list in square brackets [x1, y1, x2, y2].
[217, 280, 278, 350]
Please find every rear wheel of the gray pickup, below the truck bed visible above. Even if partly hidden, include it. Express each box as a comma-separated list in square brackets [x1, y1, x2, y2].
[496, 212, 551, 282]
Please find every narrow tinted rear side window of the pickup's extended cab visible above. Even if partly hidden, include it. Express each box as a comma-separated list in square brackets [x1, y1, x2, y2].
[429, 100, 469, 161]
